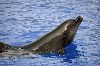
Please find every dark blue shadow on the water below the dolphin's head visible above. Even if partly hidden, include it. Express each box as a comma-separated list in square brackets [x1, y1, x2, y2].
[42, 43, 79, 63]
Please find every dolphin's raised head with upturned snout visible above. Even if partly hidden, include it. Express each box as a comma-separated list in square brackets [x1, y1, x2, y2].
[63, 16, 83, 45]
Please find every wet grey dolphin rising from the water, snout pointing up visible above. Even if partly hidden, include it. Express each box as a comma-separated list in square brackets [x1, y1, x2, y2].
[0, 16, 83, 53]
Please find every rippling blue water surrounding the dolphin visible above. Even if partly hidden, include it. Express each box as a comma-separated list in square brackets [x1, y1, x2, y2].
[0, 0, 100, 66]
